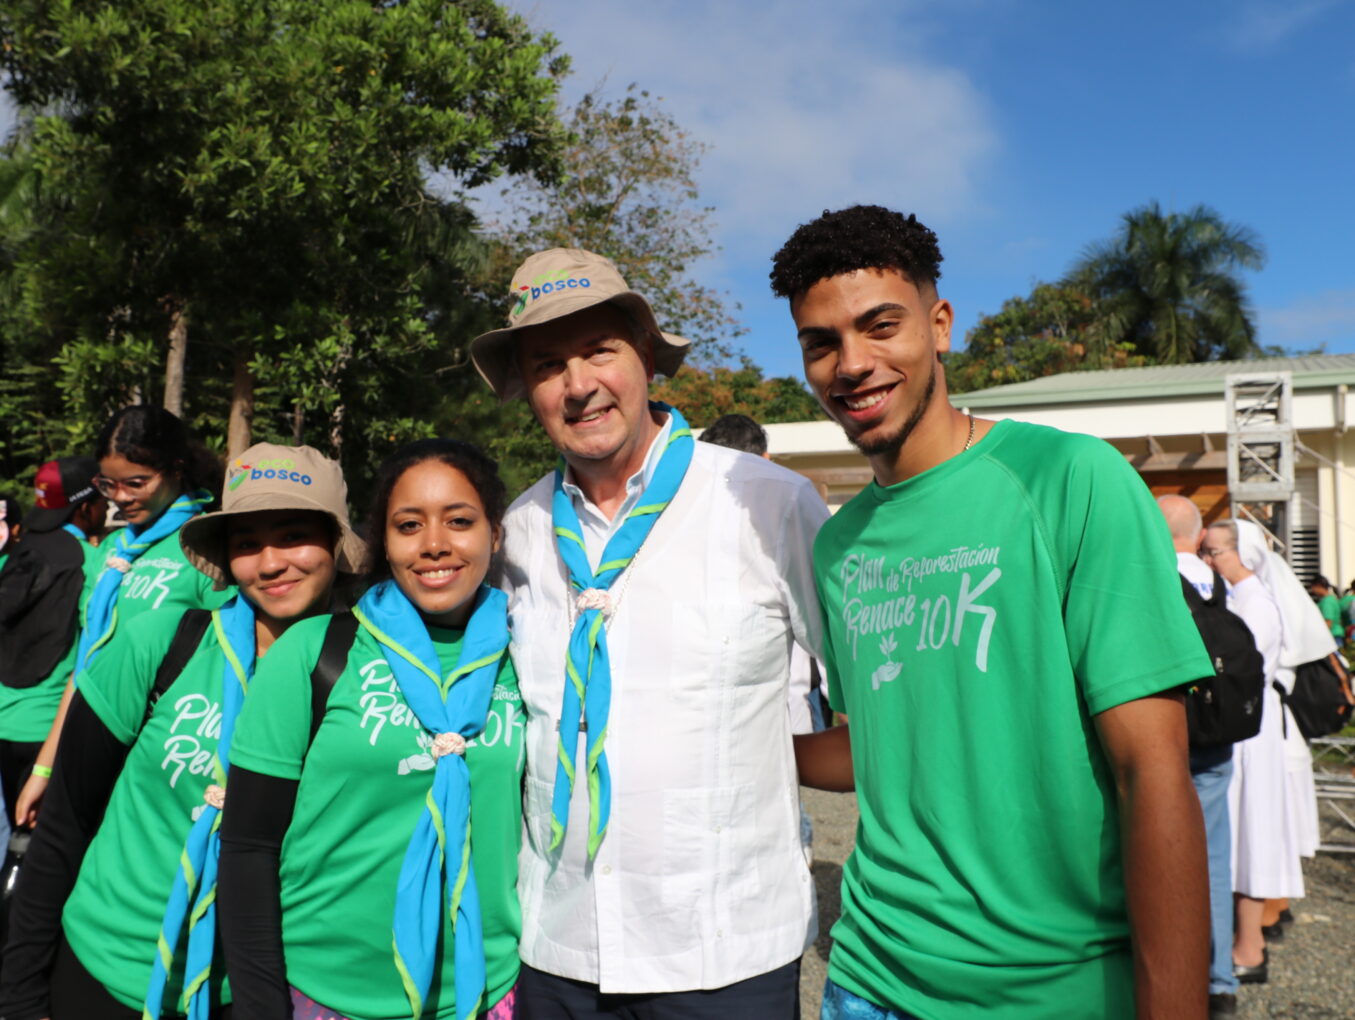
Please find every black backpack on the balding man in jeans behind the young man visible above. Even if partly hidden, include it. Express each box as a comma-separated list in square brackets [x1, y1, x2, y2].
[1182, 570, 1266, 750]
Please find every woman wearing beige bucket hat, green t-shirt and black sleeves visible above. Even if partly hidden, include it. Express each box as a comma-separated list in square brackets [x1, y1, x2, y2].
[0, 444, 364, 1020]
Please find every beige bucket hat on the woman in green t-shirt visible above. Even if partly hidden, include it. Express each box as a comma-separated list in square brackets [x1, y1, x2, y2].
[179, 443, 367, 592]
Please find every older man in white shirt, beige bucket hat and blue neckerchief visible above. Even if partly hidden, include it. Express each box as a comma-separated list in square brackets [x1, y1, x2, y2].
[472, 249, 828, 1020]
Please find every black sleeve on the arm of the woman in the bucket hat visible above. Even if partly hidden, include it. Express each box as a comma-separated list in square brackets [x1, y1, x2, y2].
[0, 691, 129, 1020]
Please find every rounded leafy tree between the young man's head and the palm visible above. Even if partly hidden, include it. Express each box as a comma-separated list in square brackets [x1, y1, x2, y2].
[944, 283, 1150, 393]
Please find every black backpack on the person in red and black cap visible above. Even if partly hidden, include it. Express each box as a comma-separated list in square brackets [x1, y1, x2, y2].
[0, 528, 84, 689]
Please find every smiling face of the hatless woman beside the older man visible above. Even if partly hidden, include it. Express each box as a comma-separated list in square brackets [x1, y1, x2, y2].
[386, 461, 499, 627]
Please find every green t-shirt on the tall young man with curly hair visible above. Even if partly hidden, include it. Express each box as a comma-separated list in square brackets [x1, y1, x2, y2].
[814, 421, 1210, 1020]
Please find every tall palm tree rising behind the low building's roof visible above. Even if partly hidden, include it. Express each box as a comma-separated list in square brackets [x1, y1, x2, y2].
[1068, 202, 1266, 364]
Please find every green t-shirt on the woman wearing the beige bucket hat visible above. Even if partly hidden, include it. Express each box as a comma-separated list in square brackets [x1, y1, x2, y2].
[62, 612, 237, 1011]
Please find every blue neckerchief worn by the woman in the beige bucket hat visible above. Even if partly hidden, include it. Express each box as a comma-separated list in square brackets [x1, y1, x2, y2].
[141, 595, 257, 1020]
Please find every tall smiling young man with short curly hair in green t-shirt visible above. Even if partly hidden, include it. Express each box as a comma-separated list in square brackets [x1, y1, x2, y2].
[771, 206, 1210, 1020]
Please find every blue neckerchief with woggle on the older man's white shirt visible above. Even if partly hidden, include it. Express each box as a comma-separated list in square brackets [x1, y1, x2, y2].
[550, 401, 695, 857]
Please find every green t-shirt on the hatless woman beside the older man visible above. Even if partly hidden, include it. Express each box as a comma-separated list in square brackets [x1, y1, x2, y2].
[230, 618, 526, 1020]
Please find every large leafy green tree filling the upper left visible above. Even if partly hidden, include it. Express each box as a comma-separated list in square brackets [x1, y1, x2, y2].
[0, 0, 565, 498]
